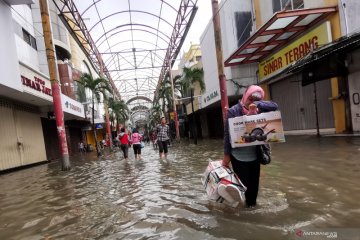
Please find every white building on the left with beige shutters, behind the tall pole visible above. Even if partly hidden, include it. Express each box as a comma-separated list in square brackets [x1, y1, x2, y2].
[0, 0, 103, 171]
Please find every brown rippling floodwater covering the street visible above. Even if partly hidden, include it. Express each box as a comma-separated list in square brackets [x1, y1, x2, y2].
[0, 136, 360, 239]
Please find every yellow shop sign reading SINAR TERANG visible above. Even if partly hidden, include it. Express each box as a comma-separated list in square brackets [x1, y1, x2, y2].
[259, 22, 331, 81]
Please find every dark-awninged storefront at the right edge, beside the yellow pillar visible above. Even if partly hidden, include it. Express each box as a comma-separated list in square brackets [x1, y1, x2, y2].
[288, 32, 360, 132]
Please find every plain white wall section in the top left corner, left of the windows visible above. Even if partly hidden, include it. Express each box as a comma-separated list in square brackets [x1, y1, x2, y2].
[0, 0, 22, 93]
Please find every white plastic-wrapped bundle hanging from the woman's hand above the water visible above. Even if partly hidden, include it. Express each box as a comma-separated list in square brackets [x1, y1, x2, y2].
[201, 161, 246, 207]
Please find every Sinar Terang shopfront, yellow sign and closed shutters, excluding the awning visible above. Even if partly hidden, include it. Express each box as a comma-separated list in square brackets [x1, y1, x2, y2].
[259, 22, 335, 130]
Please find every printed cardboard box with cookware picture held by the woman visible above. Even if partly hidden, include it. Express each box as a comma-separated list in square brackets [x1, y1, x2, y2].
[229, 111, 285, 148]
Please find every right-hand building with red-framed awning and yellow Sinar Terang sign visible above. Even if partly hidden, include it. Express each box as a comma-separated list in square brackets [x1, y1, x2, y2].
[201, 0, 359, 136]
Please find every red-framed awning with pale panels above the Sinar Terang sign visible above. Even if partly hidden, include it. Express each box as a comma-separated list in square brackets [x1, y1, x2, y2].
[225, 7, 337, 67]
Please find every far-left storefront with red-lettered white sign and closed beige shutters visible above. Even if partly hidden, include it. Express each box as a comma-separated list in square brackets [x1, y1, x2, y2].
[0, 63, 52, 170]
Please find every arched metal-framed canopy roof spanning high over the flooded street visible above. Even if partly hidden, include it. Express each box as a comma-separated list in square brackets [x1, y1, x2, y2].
[53, 0, 198, 123]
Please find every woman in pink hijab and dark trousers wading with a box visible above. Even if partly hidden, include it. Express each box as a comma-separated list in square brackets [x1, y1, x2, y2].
[223, 85, 278, 207]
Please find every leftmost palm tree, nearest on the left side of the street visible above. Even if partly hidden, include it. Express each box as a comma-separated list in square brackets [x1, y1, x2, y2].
[78, 73, 112, 156]
